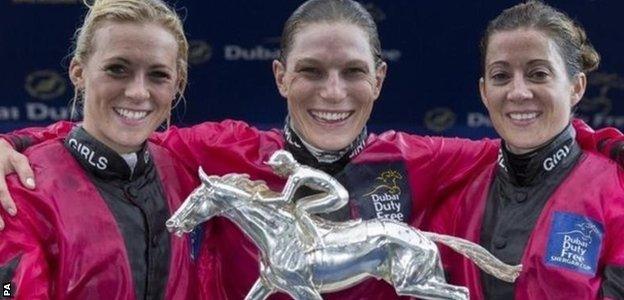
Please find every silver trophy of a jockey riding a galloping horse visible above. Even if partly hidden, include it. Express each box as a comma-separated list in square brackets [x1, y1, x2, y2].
[166, 150, 522, 299]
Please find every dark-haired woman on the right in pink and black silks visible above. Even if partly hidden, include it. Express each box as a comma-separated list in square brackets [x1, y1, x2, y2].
[433, 1, 624, 299]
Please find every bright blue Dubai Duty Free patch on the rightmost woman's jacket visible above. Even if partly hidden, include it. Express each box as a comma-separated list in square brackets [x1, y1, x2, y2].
[546, 212, 604, 275]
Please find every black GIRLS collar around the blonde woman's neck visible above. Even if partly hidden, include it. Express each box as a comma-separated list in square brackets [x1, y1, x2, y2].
[64, 126, 153, 180]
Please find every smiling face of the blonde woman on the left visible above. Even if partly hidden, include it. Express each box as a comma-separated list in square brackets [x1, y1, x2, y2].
[74, 21, 178, 153]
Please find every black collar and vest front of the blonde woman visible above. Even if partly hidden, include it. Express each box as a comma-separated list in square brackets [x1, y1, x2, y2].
[65, 127, 171, 299]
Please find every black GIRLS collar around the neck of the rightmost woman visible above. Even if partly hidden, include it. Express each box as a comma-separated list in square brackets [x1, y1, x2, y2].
[498, 124, 581, 186]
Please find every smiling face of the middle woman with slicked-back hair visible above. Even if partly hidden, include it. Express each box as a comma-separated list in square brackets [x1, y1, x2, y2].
[273, 23, 387, 151]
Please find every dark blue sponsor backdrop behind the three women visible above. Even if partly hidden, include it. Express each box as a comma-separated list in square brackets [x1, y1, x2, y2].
[0, 0, 624, 137]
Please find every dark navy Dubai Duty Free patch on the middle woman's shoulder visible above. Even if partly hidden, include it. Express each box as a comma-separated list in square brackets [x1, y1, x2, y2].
[338, 161, 412, 222]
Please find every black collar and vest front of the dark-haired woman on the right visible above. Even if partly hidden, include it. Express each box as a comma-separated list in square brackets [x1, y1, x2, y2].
[481, 125, 581, 299]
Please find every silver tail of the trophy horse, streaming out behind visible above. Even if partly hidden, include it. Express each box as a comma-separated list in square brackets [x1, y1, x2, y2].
[421, 231, 522, 282]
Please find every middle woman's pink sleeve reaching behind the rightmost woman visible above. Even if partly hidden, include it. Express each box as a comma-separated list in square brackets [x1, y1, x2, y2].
[376, 132, 499, 227]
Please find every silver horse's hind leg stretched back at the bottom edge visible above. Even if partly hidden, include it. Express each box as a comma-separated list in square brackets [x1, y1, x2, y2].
[397, 279, 470, 300]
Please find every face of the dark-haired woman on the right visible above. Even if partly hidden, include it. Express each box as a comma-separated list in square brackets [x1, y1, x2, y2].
[480, 28, 587, 154]
